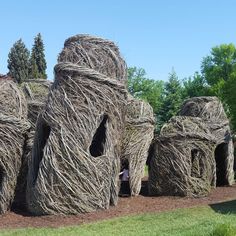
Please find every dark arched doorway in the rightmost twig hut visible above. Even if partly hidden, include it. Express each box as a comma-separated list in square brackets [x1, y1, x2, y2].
[215, 143, 228, 186]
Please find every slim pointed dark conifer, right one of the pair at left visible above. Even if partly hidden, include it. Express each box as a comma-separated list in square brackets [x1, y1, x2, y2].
[30, 33, 47, 79]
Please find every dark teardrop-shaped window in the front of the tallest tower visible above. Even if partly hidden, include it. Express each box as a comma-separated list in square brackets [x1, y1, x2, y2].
[89, 115, 108, 157]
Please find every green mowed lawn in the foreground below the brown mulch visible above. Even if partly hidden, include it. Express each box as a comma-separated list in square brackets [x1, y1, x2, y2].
[0, 201, 236, 236]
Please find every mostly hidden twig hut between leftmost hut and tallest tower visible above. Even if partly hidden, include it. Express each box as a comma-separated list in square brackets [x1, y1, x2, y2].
[14, 79, 51, 209]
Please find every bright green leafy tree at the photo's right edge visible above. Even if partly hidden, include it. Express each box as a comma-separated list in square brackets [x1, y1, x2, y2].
[202, 44, 236, 130]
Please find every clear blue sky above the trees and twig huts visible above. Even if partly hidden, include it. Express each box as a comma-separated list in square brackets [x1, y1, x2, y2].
[0, 0, 236, 80]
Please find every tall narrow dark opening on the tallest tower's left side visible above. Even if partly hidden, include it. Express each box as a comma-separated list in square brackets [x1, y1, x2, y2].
[33, 119, 51, 183]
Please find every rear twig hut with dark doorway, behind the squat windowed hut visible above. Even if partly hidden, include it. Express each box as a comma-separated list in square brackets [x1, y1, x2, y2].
[180, 97, 234, 185]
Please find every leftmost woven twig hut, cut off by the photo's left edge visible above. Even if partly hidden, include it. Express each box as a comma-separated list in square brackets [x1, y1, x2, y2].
[0, 80, 30, 213]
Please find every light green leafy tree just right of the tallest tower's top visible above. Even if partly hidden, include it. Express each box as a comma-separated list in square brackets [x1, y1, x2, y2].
[128, 67, 164, 114]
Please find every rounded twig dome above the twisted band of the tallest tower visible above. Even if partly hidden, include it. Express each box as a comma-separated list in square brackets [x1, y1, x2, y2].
[58, 34, 127, 83]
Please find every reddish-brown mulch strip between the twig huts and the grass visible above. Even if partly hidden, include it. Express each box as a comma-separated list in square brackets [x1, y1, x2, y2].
[0, 185, 236, 228]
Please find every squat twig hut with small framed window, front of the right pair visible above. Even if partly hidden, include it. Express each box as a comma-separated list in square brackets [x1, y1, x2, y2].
[148, 116, 216, 197]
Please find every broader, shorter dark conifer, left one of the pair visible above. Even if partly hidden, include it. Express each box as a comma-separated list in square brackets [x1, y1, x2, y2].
[8, 39, 30, 83]
